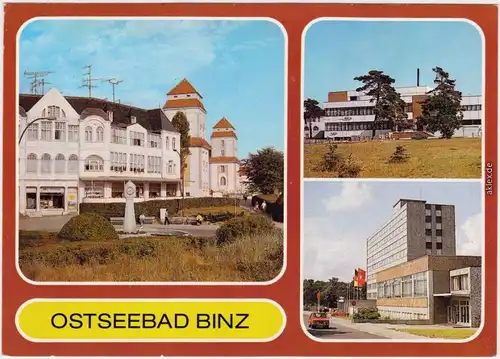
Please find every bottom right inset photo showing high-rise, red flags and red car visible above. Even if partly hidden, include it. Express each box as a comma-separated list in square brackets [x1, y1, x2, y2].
[302, 180, 484, 341]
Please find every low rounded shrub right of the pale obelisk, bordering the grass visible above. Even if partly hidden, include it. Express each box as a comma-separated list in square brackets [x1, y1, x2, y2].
[215, 214, 277, 245]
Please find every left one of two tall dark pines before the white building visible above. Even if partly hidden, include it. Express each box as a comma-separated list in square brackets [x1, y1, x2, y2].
[354, 70, 408, 138]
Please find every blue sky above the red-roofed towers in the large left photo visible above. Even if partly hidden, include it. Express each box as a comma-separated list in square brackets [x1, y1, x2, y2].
[19, 20, 285, 157]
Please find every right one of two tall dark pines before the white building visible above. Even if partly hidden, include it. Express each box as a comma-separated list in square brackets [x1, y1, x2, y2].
[418, 67, 463, 138]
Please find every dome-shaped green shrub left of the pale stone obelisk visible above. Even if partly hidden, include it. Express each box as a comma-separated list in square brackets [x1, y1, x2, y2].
[57, 213, 118, 241]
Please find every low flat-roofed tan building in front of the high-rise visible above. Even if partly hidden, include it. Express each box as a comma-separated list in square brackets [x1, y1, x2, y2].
[376, 255, 481, 328]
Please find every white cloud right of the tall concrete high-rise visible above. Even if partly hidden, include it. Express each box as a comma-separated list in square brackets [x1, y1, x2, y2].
[457, 213, 484, 256]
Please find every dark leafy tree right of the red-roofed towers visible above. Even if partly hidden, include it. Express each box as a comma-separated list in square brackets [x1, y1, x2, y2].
[241, 147, 285, 194]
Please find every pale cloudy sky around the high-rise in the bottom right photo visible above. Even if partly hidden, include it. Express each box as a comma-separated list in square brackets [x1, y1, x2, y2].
[303, 181, 484, 280]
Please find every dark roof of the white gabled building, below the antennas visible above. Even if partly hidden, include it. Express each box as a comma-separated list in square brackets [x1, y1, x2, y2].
[19, 94, 178, 132]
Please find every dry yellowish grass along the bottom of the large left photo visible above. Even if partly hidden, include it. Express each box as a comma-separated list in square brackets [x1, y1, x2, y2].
[19, 232, 283, 282]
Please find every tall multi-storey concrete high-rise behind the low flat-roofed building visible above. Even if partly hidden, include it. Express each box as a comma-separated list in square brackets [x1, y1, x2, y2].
[366, 199, 456, 299]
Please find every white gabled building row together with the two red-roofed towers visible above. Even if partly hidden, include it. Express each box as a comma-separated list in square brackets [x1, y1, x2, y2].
[18, 80, 242, 216]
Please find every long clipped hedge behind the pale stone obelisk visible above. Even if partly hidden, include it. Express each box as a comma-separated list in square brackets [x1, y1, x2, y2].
[80, 197, 240, 221]
